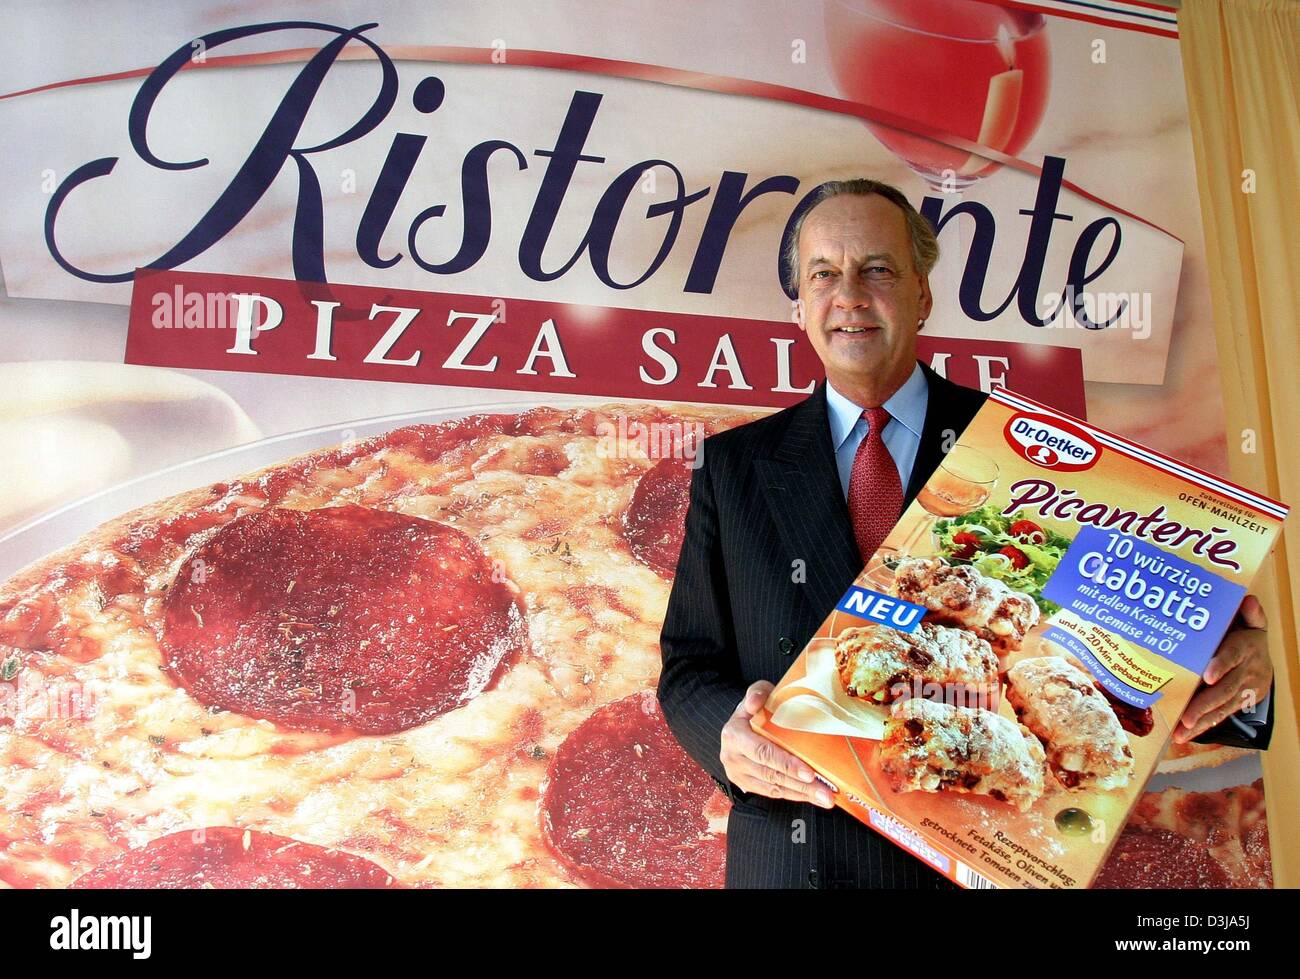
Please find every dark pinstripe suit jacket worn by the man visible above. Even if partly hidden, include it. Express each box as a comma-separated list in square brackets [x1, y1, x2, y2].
[659, 364, 1263, 888]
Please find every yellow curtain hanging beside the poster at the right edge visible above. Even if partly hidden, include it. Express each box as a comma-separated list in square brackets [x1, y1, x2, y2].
[1178, 0, 1300, 887]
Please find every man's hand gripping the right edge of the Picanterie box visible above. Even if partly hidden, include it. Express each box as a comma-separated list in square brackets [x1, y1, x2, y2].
[1174, 595, 1273, 744]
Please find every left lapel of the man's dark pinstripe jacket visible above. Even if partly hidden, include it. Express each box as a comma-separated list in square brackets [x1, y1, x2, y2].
[754, 381, 862, 614]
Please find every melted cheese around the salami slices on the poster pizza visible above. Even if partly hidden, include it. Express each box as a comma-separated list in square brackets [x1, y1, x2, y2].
[0, 406, 754, 887]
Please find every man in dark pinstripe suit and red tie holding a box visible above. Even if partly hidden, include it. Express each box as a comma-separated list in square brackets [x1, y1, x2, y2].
[659, 181, 1273, 888]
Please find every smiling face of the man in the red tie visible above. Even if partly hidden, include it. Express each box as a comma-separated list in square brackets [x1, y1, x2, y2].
[800, 194, 931, 390]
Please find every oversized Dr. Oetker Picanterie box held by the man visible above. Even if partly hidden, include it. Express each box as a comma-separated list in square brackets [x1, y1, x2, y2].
[753, 390, 1287, 888]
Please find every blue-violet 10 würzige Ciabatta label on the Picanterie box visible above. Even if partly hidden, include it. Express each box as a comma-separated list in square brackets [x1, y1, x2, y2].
[1043, 527, 1245, 681]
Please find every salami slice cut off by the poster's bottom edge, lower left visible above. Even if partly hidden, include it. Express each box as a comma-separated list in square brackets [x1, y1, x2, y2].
[72, 826, 398, 889]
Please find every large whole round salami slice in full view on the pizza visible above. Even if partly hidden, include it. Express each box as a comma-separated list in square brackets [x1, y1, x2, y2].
[163, 506, 525, 733]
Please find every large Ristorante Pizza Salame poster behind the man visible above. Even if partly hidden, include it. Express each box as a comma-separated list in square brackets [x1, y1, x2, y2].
[0, 0, 1271, 888]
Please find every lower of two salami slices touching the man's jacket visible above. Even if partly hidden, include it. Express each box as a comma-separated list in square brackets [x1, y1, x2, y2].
[541, 690, 727, 888]
